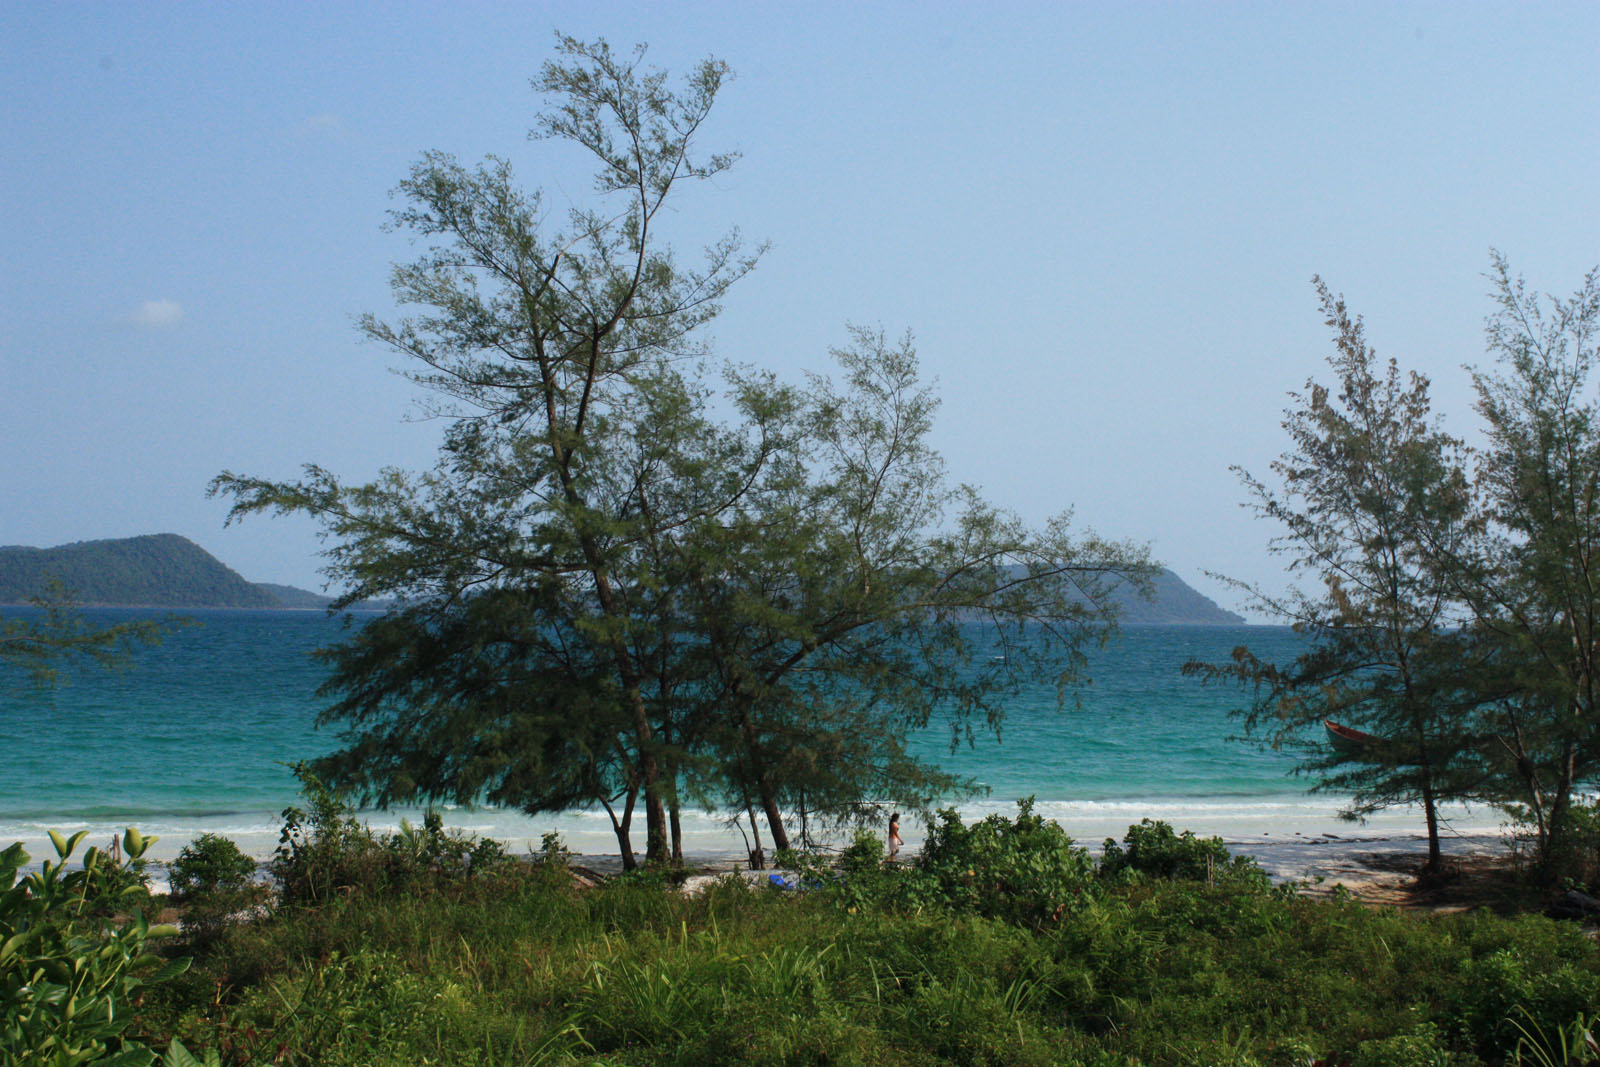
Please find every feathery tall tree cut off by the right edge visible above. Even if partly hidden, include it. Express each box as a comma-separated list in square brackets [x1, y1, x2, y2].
[1456, 253, 1600, 878]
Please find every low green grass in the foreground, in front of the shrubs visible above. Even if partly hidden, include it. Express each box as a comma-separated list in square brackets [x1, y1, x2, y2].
[121, 840, 1600, 1067]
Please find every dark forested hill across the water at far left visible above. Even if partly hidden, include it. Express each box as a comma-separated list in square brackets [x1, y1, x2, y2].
[0, 534, 280, 608]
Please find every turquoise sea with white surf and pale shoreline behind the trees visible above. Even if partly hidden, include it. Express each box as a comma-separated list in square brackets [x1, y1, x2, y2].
[0, 608, 1502, 859]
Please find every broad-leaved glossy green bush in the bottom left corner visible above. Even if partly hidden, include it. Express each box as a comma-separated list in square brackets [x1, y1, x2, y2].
[0, 827, 189, 1067]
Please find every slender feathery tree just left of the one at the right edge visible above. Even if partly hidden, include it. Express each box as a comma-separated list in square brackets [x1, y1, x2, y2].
[1186, 278, 1482, 870]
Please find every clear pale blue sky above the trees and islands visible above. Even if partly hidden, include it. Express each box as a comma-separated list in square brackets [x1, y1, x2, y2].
[0, 0, 1600, 608]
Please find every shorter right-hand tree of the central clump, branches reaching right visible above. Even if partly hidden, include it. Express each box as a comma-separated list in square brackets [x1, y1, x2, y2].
[688, 328, 1149, 848]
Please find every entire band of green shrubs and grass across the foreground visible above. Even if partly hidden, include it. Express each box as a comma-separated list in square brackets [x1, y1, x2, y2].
[9, 787, 1600, 1067]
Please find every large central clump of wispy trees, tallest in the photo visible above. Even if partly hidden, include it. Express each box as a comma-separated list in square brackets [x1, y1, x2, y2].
[213, 38, 1142, 865]
